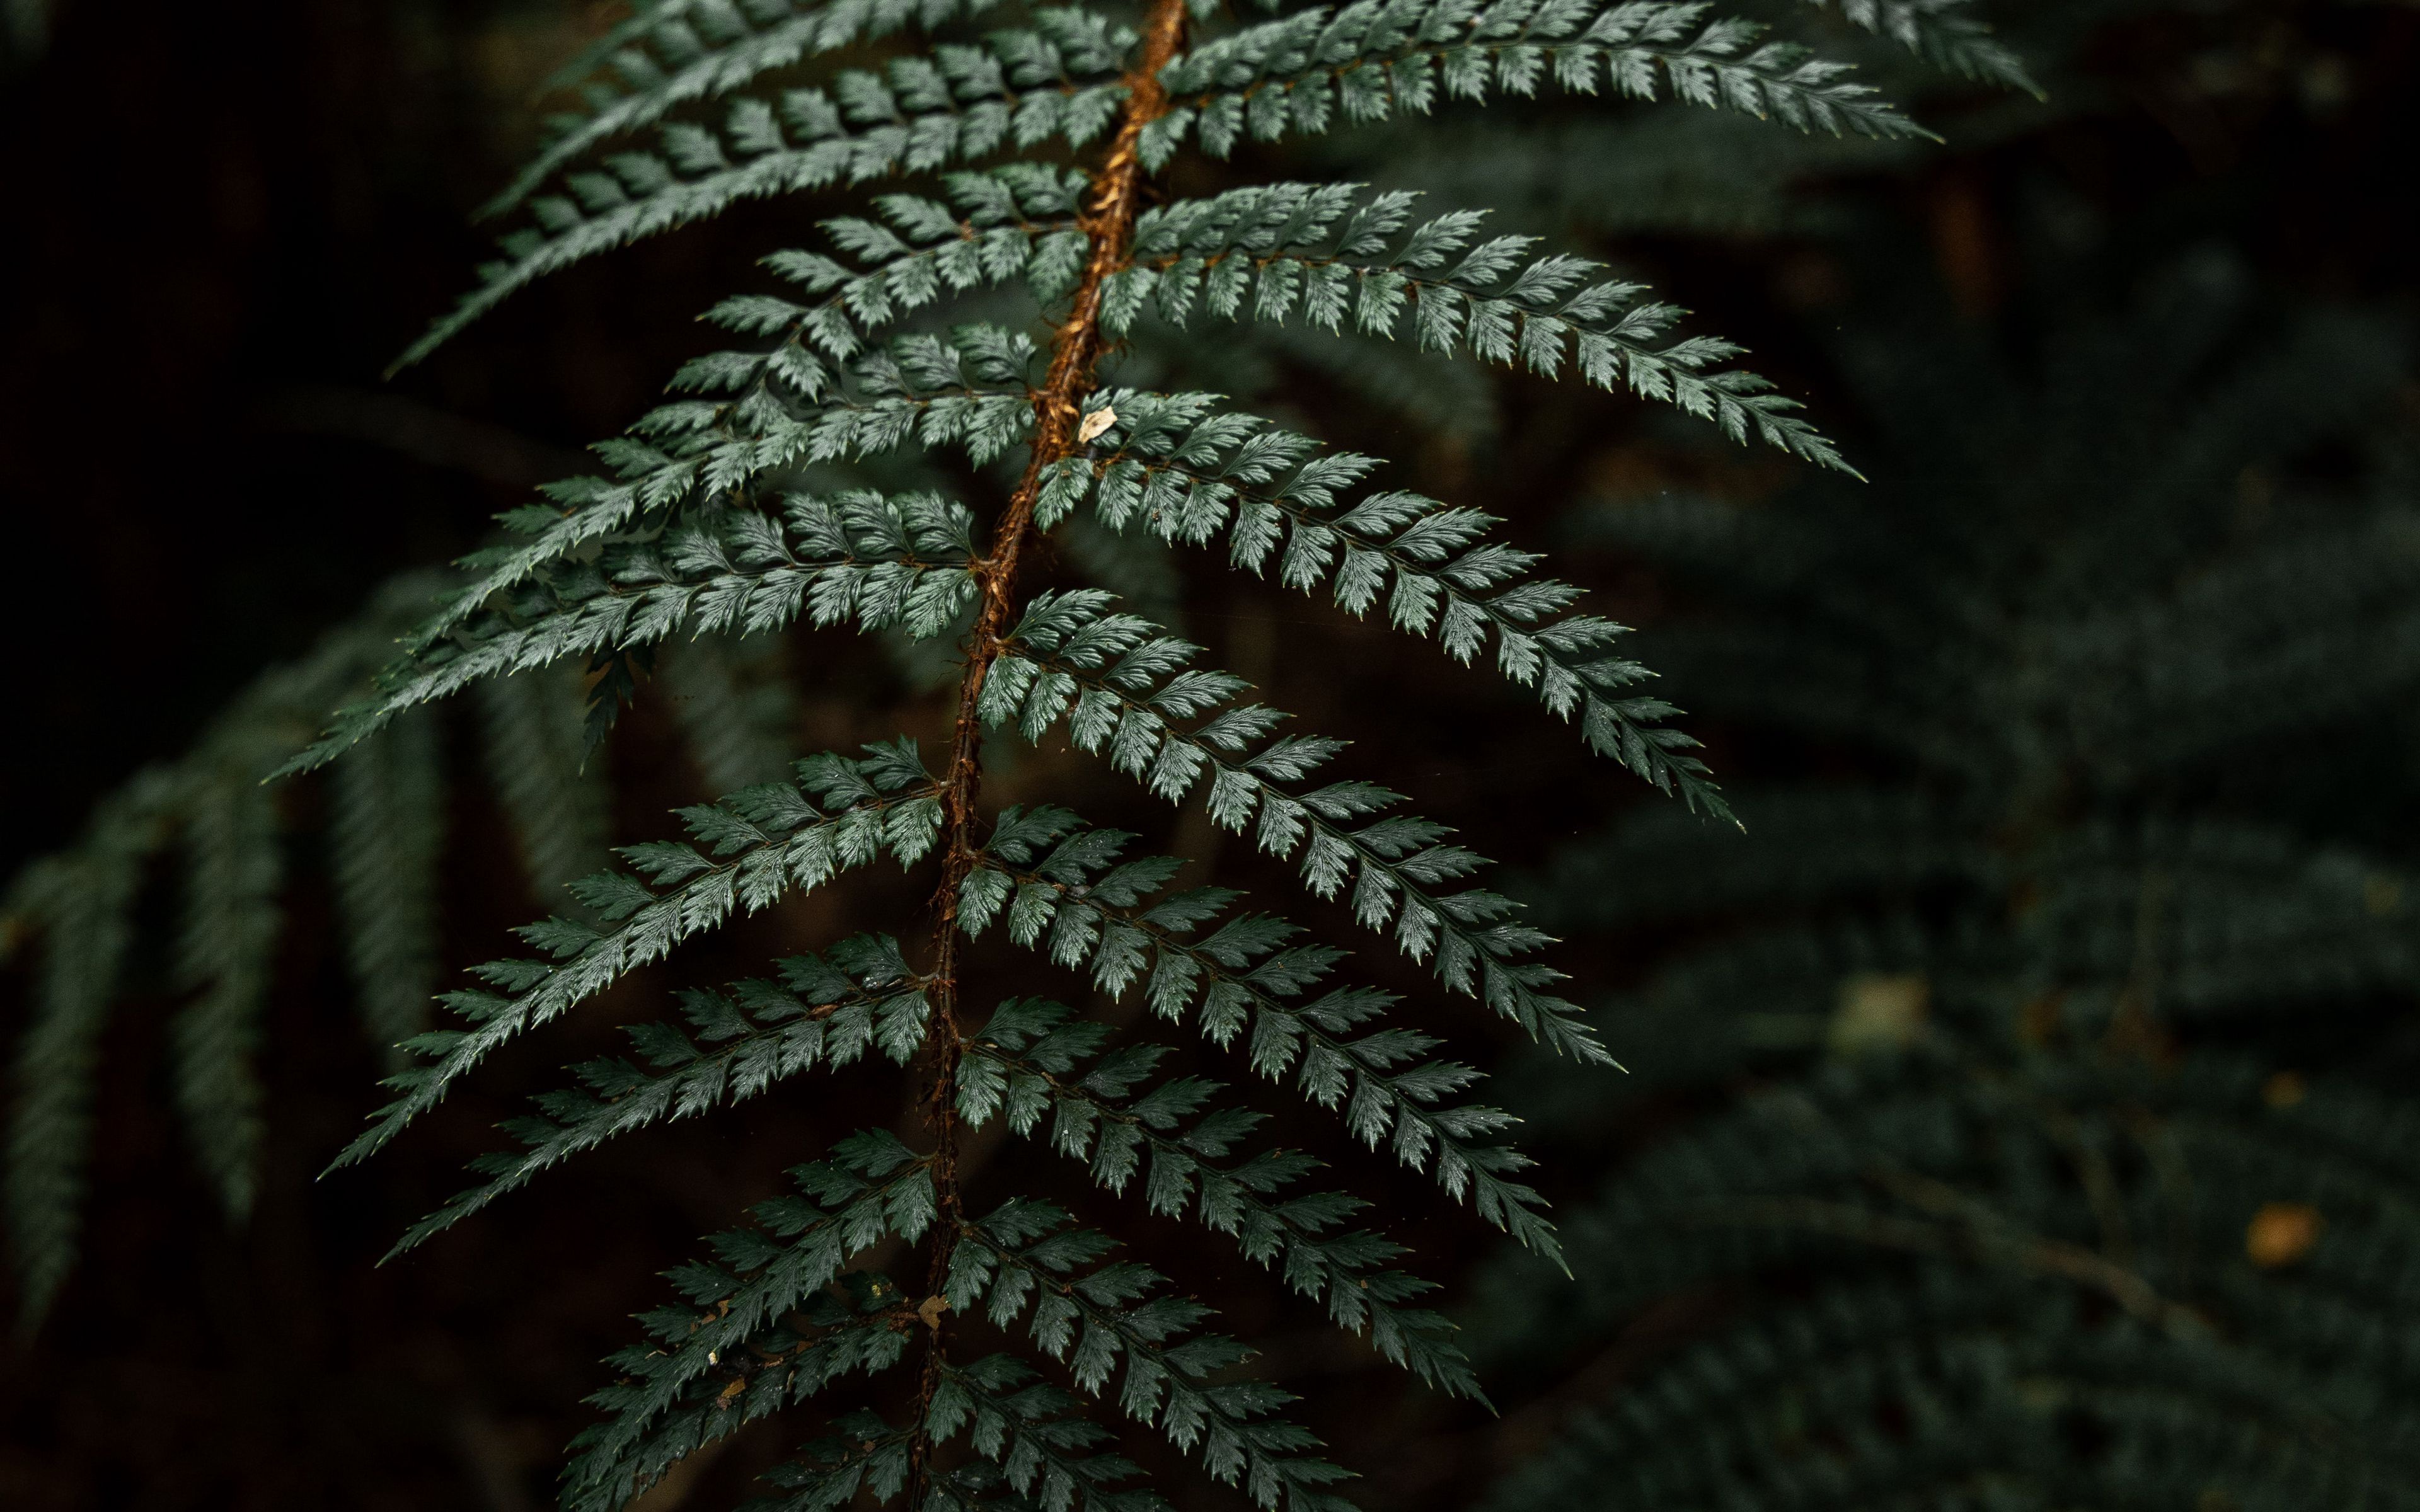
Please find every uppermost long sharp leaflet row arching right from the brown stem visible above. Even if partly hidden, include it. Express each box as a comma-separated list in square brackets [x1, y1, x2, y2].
[1144, 0, 1928, 167]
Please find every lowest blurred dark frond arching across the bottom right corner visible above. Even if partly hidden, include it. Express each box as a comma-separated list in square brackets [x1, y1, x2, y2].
[1484, 1265, 2412, 1512]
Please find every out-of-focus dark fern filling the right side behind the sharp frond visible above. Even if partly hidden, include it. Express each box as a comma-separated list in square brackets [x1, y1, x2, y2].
[1486, 259, 2420, 1509]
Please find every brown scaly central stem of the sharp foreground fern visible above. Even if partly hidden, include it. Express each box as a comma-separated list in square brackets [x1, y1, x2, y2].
[908, 0, 1186, 1512]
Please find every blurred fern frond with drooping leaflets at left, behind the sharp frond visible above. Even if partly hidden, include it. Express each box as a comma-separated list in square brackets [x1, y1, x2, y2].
[0, 573, 789, 1319]
